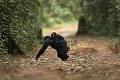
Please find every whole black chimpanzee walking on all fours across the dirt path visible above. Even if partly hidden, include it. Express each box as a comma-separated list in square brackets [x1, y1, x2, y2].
[36, 32, 70, 61]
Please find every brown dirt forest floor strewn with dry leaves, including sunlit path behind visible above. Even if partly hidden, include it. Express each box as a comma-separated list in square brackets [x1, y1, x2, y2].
[0, 24, 120, 80]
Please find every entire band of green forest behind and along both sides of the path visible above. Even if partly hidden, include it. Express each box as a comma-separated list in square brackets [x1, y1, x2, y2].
[0, 0, 120, 56]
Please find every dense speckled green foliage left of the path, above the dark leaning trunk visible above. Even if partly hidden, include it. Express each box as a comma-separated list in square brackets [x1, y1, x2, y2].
[0, 0, 39, 54]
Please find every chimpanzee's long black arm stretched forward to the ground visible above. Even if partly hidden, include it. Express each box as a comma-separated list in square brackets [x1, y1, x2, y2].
[36, 36, 51, 60]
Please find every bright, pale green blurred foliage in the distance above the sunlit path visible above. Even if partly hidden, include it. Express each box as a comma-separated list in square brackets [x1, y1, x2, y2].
[39, 0, 80, 27]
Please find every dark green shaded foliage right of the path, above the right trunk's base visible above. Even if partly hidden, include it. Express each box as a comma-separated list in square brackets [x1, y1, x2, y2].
[81, 0, 120, 36]
